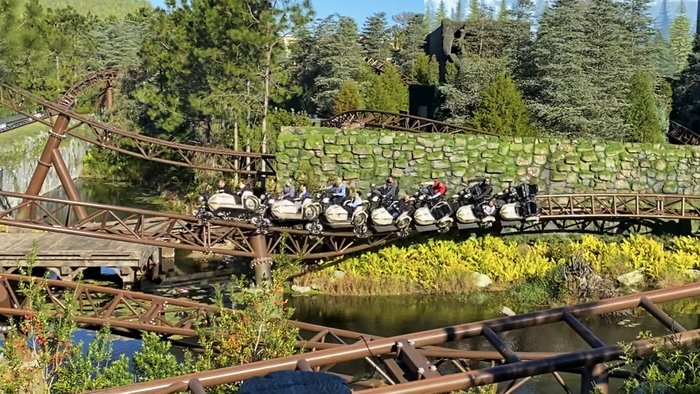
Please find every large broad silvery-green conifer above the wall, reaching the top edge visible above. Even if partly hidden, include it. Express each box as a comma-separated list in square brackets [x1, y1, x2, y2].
[528, 0, 634, 139]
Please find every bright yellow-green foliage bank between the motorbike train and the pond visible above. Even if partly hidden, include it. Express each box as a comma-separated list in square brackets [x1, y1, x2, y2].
[302, 235, 700, 296]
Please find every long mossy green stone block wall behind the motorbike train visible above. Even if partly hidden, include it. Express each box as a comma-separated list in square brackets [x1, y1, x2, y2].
[277, 127, 700, 194]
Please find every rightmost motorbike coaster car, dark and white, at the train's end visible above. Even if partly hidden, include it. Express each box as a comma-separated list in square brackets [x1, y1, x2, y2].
[496, 182, 540, 227]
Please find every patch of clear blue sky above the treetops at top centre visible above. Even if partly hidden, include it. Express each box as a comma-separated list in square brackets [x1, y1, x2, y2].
[151, 0, 424, 26]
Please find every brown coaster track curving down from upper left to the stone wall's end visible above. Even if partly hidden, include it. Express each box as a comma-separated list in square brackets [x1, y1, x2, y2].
[0, 81, 275, 175]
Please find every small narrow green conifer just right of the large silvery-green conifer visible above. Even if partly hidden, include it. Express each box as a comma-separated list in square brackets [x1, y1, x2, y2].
[626, 72, 662, 143]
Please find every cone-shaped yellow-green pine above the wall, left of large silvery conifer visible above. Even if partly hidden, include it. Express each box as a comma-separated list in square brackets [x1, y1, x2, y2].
[469, 74, 538, 137]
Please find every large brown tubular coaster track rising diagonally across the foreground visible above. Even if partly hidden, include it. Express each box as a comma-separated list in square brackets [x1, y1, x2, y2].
[87, 283, 700, 394]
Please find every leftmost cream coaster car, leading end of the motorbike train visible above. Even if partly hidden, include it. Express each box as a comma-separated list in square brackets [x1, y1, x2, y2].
[193, 191, 262, 221]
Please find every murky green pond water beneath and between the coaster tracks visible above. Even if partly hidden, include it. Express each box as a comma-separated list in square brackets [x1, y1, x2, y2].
[53, 180, 700, 394]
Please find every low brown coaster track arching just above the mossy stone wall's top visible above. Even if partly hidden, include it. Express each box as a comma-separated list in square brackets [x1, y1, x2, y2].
[321, 109, 498, 136]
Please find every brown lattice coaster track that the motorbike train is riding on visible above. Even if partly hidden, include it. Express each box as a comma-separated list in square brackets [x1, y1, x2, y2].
[0, 191, 700, 260]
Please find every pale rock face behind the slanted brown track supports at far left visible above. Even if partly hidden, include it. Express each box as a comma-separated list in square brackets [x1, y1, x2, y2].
[0, 127, 89, 206]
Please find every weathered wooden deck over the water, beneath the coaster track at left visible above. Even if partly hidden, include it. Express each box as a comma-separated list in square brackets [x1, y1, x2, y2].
[0, 232, 161, 287]
